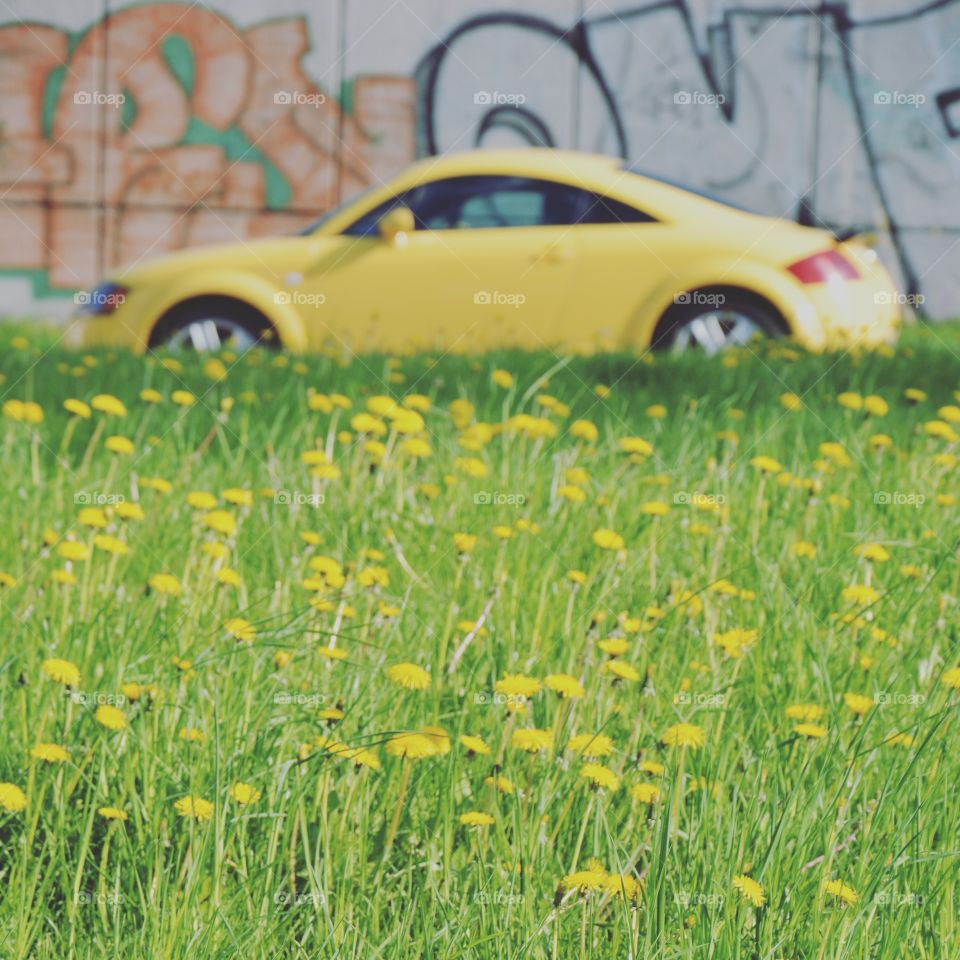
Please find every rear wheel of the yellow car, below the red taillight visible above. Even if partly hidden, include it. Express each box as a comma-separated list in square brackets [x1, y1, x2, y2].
[651, 290, 787, 355]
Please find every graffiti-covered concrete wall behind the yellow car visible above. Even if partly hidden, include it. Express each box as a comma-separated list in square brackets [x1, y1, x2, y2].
[0, 0, 960, 316]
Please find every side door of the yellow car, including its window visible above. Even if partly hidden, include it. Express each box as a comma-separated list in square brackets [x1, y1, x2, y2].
[301, 175, 579, 350]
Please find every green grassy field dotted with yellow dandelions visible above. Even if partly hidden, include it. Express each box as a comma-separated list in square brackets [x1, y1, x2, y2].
[0, 327, 960, 960]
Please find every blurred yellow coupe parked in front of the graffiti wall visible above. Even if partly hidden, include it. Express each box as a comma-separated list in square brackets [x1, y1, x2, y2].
[73, 149, 902, 353]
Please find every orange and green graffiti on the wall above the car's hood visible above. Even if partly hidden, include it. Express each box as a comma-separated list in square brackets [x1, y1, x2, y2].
[0, 3, 415, 290]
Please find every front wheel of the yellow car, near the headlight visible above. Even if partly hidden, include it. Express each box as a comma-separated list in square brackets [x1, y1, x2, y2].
[150, 297, 280, 353]
